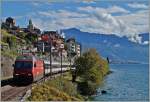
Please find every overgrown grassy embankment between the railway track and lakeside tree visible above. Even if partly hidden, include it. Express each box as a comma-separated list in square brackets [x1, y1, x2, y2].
[28, 73, 84, 101]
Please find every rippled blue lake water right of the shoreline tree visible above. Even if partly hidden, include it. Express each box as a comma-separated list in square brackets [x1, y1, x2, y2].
[94, 64, 149, 101]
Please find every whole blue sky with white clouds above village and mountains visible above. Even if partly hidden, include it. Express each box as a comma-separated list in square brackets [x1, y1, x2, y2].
[1, 0, 149, 43]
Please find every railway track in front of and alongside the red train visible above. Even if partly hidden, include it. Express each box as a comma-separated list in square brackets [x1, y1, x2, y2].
[1, 71, 71, 101]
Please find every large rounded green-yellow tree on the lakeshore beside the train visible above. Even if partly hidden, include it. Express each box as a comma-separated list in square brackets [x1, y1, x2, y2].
[75, 49, 108, 94]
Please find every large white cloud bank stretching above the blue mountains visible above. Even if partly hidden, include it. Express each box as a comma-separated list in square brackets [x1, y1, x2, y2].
[33, 6, 148, 43]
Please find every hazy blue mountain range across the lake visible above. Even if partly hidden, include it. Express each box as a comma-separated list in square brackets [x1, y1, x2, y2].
[63, 28, 149, 63]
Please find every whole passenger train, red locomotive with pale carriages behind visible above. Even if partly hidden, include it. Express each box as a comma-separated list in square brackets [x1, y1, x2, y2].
[13, 54, 69, 82]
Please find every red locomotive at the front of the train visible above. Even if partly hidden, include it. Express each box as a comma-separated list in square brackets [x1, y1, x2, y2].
[13, 54, 44, 82]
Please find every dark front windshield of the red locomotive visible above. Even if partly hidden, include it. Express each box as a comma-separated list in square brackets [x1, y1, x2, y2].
[15, 61, 33, 69]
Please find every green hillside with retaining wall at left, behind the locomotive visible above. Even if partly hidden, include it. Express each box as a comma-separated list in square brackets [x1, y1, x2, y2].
[0, 29, 32, 79]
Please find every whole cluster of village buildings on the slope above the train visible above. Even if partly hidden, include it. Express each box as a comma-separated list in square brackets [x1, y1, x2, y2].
[1, 17, 81, 59]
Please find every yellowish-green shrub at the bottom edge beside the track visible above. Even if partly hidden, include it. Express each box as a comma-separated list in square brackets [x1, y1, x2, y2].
[28, 84, 71, 101]
